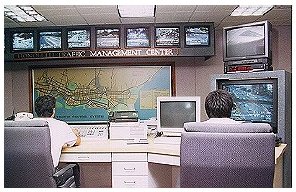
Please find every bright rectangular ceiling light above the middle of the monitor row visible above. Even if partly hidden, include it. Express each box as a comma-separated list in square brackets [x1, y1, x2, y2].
[117, 5, 155, 17]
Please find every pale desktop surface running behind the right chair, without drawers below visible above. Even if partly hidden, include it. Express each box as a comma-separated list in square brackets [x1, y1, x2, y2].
[62, 139, 287, 163]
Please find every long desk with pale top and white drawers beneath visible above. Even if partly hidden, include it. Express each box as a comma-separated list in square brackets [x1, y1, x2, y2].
[60, 139, 286, 187]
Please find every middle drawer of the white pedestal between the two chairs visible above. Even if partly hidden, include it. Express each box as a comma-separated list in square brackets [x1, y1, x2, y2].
[112, 162, 148, 175]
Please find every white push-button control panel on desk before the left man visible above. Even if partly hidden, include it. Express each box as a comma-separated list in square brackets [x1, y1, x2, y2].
[70, 124, 108, 140]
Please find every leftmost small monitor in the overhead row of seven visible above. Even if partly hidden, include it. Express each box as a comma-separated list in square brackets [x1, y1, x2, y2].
[12, 32, 34, 51]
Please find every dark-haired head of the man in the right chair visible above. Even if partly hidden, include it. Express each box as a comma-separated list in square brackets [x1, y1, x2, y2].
[205, 89, 234, 118]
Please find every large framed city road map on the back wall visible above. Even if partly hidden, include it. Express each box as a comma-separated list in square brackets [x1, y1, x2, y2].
[32, 66, 171, 122]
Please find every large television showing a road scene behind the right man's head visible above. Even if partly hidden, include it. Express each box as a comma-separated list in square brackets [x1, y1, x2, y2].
[217, 78, 278, 133]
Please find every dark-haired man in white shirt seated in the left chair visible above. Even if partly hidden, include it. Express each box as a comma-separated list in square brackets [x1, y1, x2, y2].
[35, 95, 81, 167]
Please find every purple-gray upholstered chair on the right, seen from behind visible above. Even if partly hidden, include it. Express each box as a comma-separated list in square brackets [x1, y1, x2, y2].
[180, 123, 275, 188]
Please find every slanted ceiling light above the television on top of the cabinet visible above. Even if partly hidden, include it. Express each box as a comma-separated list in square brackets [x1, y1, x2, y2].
[231, 5, 273, 16]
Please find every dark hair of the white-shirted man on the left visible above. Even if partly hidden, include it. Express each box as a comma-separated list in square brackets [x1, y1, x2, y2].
[35, 95, 56, 117]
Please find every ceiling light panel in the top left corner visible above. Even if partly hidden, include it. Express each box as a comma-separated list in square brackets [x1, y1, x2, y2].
[4, 5, 46, 22]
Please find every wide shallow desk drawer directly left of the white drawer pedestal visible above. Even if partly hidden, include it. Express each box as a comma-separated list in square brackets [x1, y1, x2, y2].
[60, 153, 111, 162]
